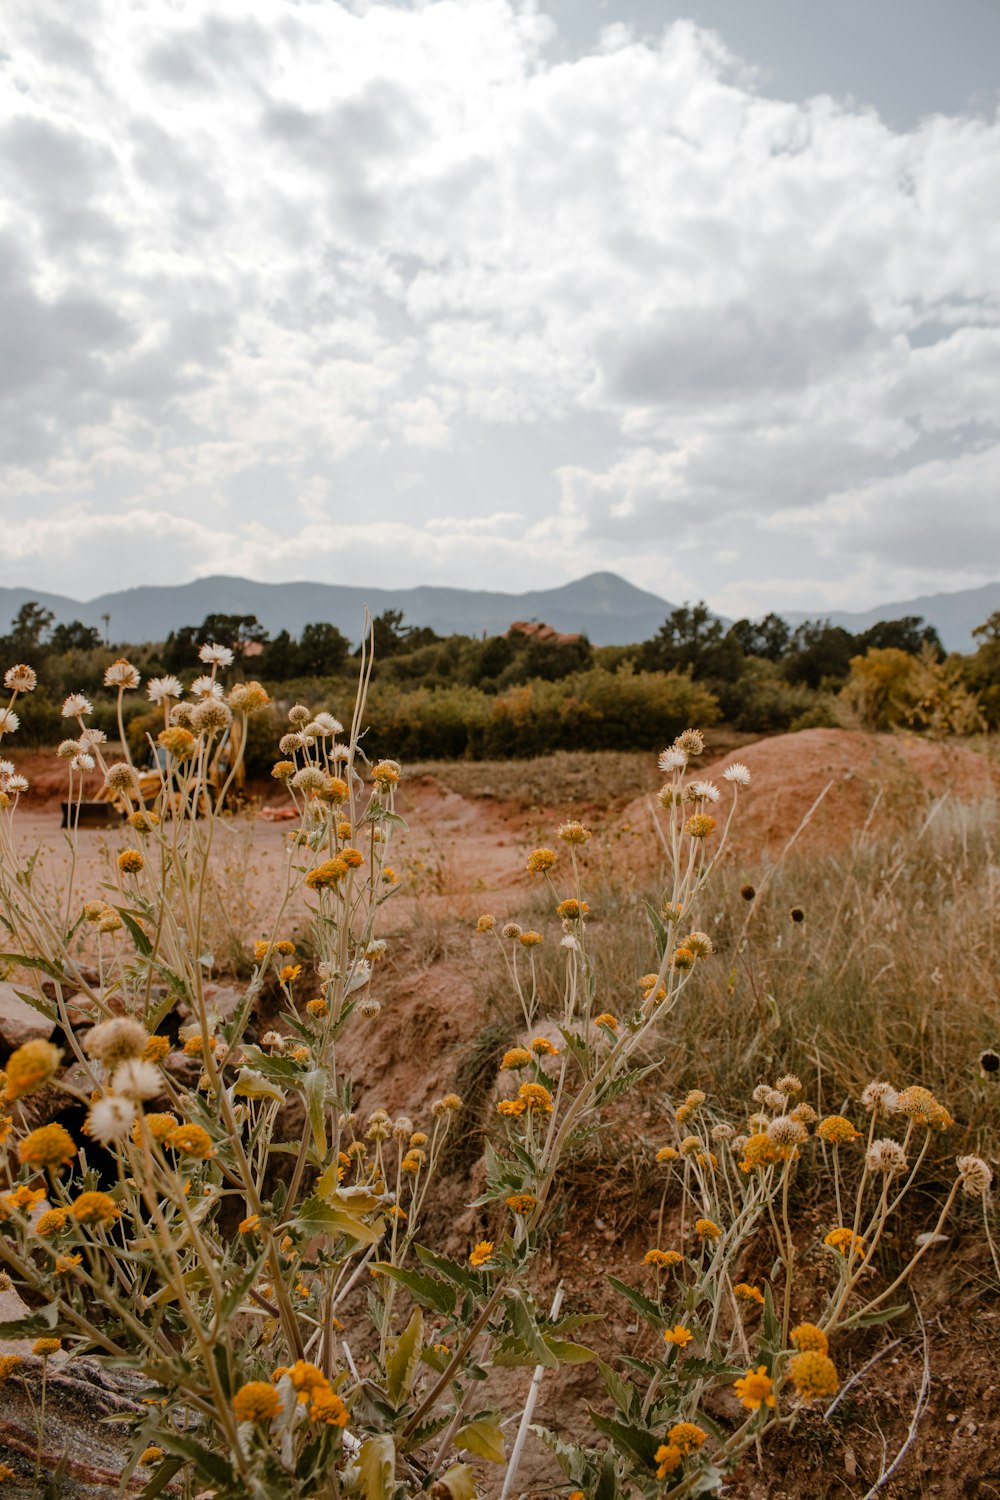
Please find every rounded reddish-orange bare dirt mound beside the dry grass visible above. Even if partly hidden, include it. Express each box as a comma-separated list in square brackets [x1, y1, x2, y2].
[703, 729, 1000, 855]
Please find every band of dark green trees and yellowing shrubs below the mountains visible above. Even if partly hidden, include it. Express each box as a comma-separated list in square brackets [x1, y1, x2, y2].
[0, 603, 1000, 773]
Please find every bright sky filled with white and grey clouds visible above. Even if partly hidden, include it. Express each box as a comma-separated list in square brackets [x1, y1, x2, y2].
[0, 0, 1000, 615]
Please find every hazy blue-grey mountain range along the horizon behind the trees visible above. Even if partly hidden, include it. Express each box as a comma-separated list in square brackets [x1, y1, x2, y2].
[0, 573, 1000, 651]
